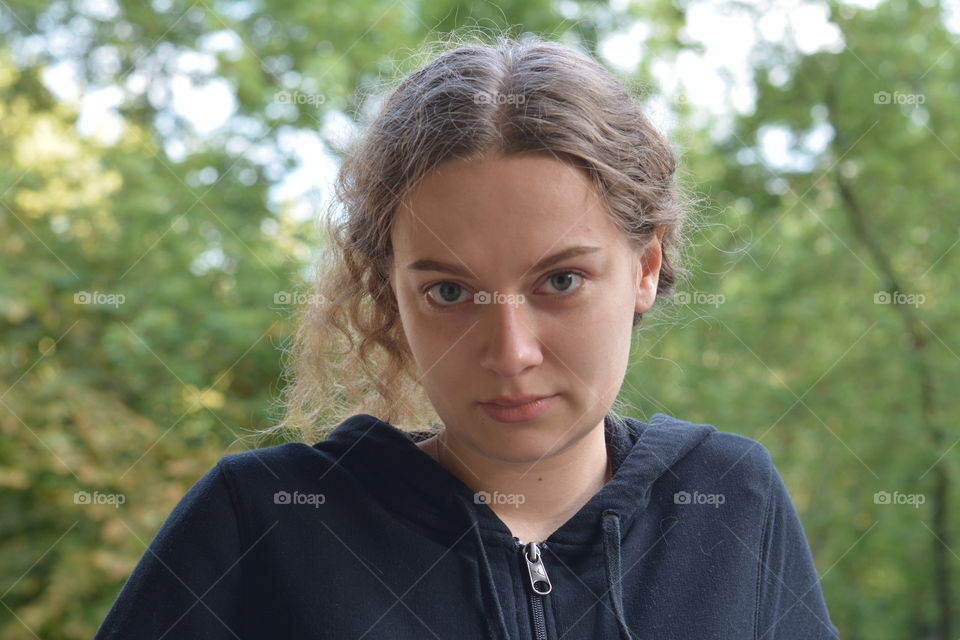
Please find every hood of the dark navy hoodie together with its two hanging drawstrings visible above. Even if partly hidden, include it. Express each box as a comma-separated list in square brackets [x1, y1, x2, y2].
[327, 413, 717, 640]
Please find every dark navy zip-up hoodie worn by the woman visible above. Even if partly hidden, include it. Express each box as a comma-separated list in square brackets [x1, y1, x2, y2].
[95, 414, 839, 640]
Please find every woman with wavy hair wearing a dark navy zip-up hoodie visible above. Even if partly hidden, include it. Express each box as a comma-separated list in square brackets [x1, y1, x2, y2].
[97, 39, 838, 640]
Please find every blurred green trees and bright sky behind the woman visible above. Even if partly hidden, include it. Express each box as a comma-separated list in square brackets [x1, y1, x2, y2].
[0, 0, 960, 640]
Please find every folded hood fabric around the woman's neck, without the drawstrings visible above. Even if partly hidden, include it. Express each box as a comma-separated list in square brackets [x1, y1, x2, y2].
[314, 413, 716, 548]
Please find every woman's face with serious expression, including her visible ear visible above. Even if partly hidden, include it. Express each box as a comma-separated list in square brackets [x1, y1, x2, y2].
[390, 153, 660, 462]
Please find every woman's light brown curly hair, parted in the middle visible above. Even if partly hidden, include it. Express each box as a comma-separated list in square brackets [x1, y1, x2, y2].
[258, 28, 688, 443]
